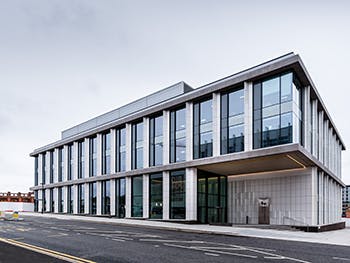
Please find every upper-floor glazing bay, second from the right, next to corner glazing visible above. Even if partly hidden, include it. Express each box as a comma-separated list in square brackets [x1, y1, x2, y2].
[220, 88, 244, 154]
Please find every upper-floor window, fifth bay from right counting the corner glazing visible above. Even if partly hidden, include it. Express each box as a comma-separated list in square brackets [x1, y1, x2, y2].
[149, 116, 163, 166]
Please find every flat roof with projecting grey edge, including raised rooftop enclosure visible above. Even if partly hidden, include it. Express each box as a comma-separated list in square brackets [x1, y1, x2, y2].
[30, 52, 345, 156]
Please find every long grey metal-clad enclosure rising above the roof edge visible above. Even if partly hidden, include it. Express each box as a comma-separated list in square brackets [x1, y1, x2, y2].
[62, 82, 193, 139]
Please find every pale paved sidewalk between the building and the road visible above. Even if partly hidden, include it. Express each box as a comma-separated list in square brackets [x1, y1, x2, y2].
[20, 212, 350, 249]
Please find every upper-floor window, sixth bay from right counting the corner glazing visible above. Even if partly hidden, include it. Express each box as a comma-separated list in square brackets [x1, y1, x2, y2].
[131, 122, 143, 169]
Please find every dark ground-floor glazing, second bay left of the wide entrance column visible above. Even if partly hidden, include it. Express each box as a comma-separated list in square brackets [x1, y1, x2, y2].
[149, 173, 163, 219]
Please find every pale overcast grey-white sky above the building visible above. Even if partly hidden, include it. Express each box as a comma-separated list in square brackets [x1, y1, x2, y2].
[0, 0, 350, 192]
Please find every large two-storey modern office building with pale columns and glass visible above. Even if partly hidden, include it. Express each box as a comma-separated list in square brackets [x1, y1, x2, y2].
[30, 53, 345, 226]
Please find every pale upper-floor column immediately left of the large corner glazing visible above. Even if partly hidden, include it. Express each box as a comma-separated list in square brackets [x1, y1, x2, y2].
[244, 81, 253, 151]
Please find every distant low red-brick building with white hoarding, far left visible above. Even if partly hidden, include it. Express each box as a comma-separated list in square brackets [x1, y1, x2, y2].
[0, 192, 34, 212]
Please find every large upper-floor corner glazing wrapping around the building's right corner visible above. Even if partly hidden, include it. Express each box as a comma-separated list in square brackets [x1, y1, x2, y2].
[253, 72, 303, 149]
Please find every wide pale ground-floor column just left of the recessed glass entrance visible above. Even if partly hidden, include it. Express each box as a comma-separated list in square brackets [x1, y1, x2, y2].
[186, 168, 197, 221]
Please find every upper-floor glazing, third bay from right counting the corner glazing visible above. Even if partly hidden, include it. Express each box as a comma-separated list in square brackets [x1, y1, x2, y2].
[193, 99, 213, 159]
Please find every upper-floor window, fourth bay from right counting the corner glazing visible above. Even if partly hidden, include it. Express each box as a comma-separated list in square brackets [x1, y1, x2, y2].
[170, 108, 186, 163]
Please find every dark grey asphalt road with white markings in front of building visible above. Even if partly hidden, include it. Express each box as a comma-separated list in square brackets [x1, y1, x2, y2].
[0, 216, 350, 263]
